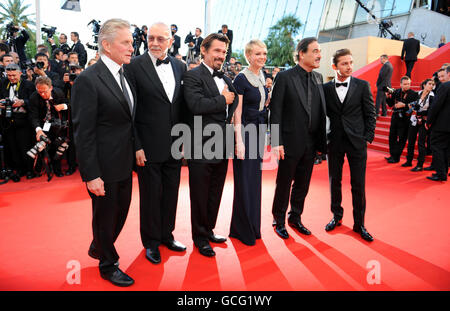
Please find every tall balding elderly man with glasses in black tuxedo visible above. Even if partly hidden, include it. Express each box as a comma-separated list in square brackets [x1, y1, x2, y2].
[127, 23, 186, 264]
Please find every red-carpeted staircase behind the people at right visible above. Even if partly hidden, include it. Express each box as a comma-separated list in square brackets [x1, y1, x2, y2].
[353, 43, 450, 162]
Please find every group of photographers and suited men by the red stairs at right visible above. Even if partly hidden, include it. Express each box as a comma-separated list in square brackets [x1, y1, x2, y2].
[376, 32, 450, 181]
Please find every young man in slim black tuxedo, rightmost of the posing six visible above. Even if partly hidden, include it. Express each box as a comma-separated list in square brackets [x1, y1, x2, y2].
[323, 49, 376, 242]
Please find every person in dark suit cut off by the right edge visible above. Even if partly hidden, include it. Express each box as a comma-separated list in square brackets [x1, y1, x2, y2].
[426, 71, 450, 181]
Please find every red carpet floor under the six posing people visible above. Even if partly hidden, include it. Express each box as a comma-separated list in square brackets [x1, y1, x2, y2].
[0, 151, 450, 291]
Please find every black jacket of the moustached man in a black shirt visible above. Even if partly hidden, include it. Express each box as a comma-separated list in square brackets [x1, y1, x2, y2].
[270, 65, 327, 157]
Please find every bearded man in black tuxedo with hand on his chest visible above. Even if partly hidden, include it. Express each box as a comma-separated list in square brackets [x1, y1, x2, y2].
[183, 33, 238, 257]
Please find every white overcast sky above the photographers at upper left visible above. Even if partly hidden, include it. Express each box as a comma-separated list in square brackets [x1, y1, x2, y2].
[24, 0, 204, 56]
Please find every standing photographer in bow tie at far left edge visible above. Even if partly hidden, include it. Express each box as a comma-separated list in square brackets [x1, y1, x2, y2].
[0, 63, 35, 181]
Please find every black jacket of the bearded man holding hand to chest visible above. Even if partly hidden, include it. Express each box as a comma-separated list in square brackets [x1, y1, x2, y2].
[183, 64, 239, 163]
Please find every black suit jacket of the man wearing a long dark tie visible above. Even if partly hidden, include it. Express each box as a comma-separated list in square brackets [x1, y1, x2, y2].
[71, 59, 137, 183]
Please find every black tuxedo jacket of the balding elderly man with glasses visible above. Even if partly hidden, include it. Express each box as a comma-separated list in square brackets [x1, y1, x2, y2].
[126, 53, 186, 163]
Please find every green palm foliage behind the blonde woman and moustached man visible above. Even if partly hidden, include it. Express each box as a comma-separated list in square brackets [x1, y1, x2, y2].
[265, 15, 302, 66]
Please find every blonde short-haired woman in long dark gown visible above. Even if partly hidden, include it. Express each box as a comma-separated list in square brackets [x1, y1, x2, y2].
[230, 40, 269, 245]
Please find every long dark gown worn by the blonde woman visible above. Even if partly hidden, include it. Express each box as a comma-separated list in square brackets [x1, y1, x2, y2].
[230, 73, 268, 245]
